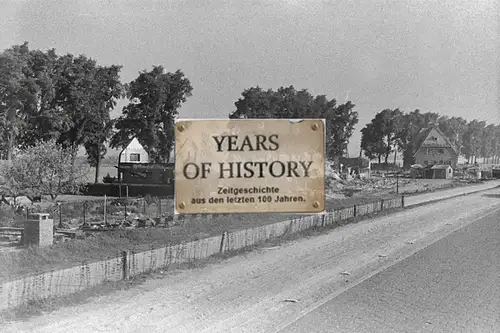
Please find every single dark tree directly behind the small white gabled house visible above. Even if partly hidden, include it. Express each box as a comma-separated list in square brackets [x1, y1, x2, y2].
[110, 66, 193, 162]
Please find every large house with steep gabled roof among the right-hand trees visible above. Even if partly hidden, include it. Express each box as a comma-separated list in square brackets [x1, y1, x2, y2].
[413, 126, 458, 167]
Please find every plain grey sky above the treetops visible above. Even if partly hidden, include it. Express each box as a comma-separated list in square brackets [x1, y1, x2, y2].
[0, 0, 500, 156]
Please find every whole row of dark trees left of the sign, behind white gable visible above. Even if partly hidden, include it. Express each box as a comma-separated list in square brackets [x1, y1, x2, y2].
[0, 42, 192, 181]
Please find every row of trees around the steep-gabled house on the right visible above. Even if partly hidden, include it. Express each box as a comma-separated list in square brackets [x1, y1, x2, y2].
[361, 109, 500, 166]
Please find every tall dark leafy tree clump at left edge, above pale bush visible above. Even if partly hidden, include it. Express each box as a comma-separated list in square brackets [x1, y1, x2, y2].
[0, 43, 121, 165]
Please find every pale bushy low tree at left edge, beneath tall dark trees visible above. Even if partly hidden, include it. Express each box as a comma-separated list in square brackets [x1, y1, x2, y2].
[1, 139, 88, 200]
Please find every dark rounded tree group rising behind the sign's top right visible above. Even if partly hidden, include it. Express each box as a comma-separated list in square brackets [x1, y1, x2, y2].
[229, 86, 358, 161]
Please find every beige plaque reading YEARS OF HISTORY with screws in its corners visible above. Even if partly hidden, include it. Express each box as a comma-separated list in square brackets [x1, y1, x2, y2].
[175, 119, 325, 214]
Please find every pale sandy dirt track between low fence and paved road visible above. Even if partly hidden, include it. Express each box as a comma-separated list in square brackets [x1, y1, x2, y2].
[0, 189, 500, 333]
